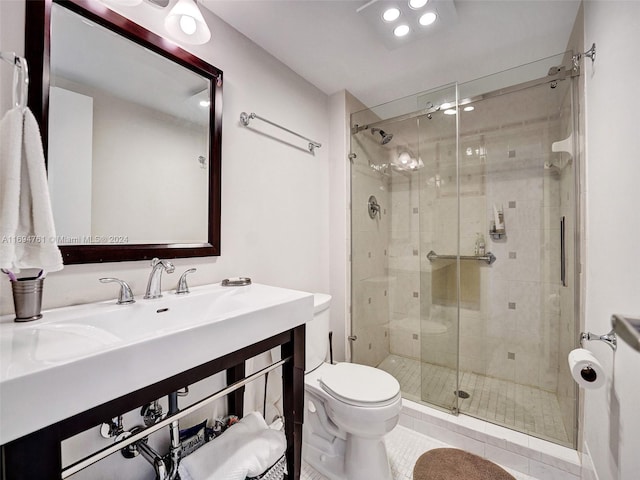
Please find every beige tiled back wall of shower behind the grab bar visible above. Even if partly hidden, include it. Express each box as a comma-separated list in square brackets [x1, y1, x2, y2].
[389, 80, 562, 392]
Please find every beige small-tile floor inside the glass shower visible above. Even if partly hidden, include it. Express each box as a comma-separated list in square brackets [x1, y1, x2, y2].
[378, 355, 572, 447]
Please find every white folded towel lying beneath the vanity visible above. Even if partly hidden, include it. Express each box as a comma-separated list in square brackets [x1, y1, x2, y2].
[178, 412, 287, 480]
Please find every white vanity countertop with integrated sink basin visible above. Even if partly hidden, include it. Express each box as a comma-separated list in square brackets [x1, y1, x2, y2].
[0, 284, 313, 445]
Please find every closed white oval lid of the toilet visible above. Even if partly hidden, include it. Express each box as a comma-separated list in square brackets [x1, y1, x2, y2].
[320, 363, 400, 405]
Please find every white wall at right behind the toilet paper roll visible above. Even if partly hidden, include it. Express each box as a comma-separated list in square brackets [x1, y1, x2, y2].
[583, 1, 640, 480]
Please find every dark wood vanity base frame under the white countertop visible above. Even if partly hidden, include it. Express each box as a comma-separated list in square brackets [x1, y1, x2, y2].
[2, 324, 305, 480]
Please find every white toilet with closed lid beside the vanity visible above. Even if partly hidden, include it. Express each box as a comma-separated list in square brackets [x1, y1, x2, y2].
[302, 294, 402, 480]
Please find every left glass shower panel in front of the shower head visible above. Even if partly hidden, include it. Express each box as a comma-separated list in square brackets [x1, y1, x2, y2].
[351, 85, 458, 411]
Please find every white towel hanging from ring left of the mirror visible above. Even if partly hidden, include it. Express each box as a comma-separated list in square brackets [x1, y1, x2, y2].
[0, 108, 63, 272]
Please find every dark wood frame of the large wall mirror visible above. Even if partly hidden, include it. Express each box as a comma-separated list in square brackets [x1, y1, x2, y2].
[25, 0, 222, 265]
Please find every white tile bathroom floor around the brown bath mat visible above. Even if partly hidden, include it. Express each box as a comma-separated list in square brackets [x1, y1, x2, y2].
[301, 425, 536, 480]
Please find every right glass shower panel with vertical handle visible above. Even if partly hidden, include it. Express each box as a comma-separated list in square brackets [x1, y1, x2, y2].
[459, 73, 575, 446]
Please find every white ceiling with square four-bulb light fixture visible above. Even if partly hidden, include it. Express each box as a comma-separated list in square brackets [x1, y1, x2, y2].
[198, 0, 580, 106]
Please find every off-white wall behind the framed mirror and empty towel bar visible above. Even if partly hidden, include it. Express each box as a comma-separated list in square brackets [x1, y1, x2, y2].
[0, 1, 329, 313]
